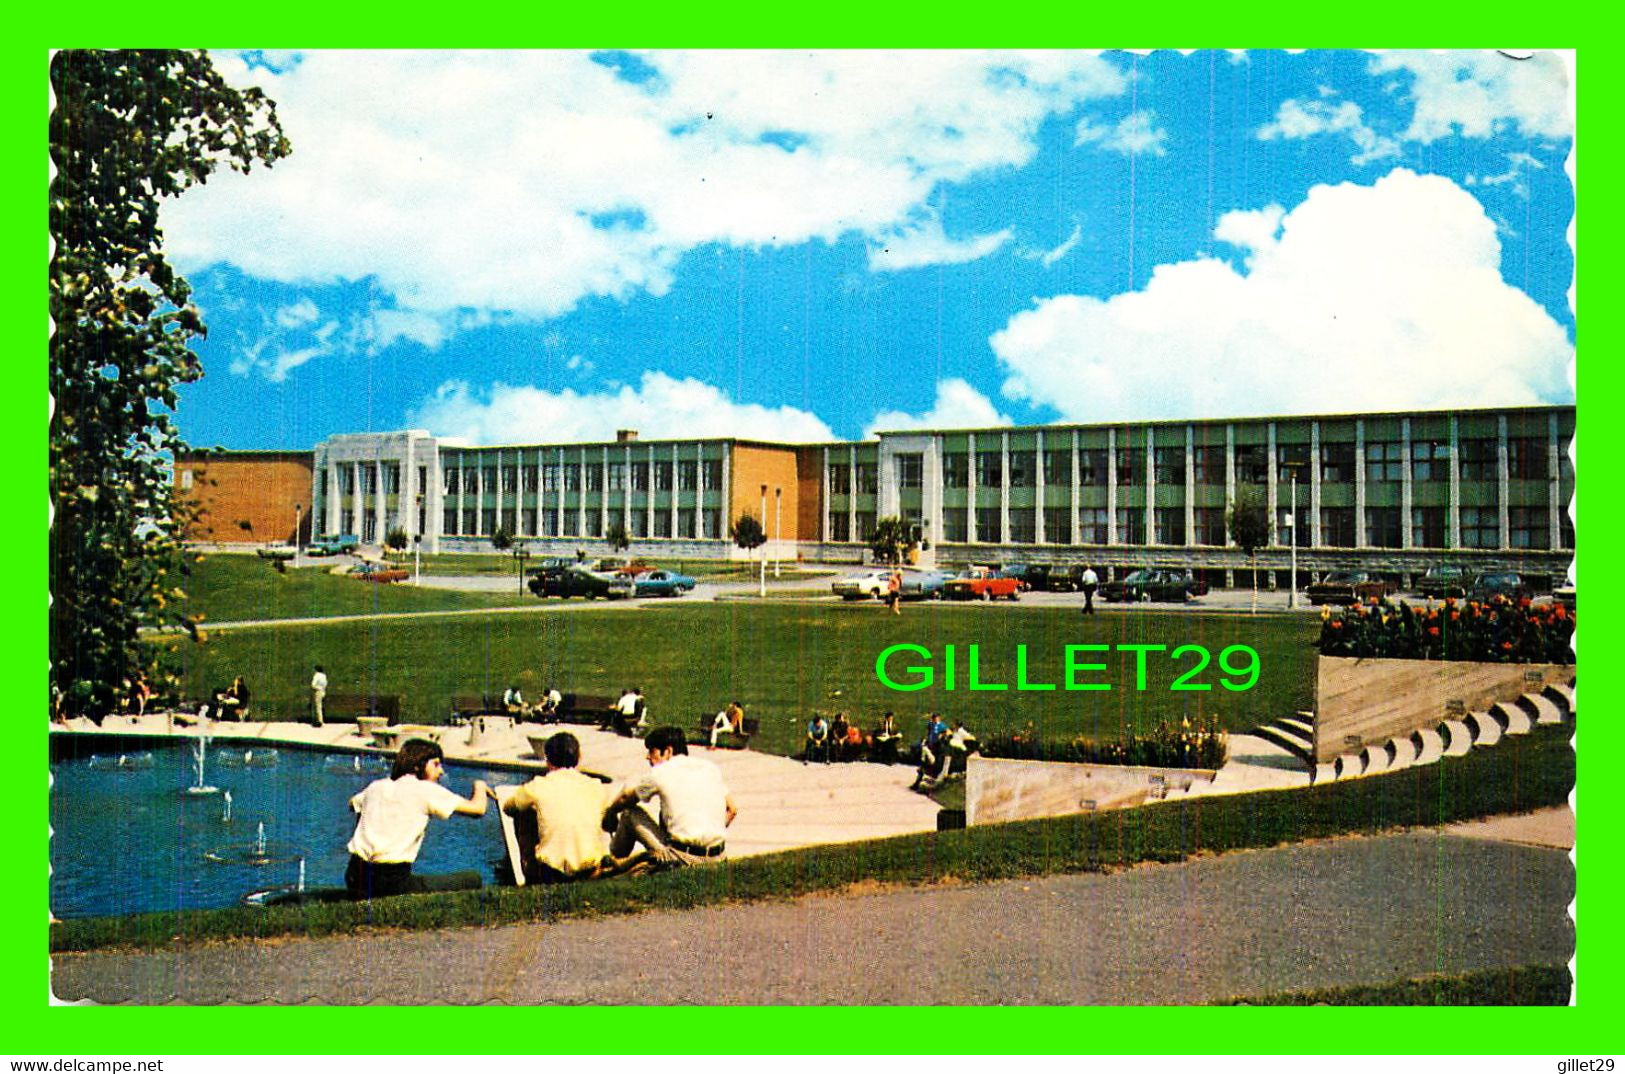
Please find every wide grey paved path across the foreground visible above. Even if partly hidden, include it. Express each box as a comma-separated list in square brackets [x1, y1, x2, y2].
[54, 832, 1575, 1004]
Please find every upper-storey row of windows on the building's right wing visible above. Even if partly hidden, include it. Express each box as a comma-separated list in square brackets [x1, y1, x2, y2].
[916, 437, 1568, 491]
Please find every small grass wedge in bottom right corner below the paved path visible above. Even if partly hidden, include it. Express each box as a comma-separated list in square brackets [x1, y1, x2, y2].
[1214, 965, 1575, 1007]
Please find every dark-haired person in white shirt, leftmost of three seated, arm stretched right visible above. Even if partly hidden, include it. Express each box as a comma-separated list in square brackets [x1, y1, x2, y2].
[345, 738, 491, 899]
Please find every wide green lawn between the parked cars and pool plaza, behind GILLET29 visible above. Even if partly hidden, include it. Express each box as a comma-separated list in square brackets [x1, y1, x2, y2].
[161, 597, 1320, 754]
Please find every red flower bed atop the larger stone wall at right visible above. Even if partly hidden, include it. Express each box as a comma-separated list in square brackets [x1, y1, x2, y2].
[1320, 596, 1575, 665]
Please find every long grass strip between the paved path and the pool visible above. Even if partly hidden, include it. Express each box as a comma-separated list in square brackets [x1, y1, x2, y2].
[50, 714, 1575, 951]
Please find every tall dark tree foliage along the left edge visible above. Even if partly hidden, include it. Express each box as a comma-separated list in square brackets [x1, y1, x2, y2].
[49, 50, 289, 717]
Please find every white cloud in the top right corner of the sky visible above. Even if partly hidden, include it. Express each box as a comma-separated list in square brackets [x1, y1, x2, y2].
[1372, 52, 1575, 143]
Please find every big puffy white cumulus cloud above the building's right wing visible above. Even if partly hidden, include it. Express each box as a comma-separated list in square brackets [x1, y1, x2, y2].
[990, 169, 1573, 421]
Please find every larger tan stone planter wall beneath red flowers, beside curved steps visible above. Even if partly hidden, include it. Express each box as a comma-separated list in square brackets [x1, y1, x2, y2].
[1315, 656, 1575, 762]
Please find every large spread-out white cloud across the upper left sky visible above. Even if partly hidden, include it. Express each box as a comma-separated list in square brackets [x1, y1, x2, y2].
[164, 50, 1126, 331]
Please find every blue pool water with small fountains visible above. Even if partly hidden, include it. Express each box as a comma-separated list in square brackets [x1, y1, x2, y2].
[50, 743, 523, 918]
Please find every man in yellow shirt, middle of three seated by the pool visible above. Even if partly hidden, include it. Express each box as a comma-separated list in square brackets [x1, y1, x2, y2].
[504, 731, 614, 884]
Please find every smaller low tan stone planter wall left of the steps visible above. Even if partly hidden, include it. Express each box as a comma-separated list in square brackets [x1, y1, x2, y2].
[965, 754, 1217, 824]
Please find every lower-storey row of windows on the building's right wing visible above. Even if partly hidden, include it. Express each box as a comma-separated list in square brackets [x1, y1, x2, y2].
[829, 507, 1575, 549]
